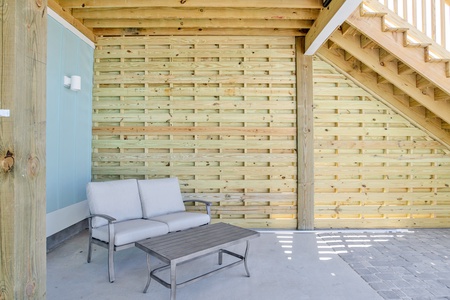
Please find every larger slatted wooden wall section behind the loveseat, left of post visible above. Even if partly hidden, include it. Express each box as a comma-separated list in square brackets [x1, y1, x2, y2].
[92, 37, 297, 228]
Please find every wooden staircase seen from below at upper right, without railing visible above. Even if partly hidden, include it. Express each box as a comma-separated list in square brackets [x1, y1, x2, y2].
[318, 0, 450, 148]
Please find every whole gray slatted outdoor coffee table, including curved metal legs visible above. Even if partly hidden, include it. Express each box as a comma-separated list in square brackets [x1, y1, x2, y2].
[136, 223, 259, 300]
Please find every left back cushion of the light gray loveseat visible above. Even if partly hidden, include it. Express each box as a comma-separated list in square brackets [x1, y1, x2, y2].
[86, 179, 142, 228]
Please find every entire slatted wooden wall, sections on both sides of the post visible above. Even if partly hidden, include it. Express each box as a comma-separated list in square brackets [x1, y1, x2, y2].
[92, 37, 450, 228]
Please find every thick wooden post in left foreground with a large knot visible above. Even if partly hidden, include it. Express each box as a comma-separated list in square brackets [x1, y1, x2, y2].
[0, 0, 47, 299]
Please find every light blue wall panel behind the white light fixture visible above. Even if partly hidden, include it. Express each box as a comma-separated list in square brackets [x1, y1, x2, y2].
[46, 16, 94, 216]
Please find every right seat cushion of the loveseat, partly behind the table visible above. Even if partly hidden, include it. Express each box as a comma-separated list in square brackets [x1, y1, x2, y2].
[151, 212, 211, 232]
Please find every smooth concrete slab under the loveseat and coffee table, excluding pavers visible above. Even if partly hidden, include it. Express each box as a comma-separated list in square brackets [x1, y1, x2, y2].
[47, 231, 383, 300]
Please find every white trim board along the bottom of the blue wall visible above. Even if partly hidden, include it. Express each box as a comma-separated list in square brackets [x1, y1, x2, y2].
[46, 200, 89, 237]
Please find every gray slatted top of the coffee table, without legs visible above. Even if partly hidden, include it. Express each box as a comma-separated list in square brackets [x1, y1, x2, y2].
[136, 223, 259, 263]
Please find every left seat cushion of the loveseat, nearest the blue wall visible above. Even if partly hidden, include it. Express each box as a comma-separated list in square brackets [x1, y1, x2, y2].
[92, 219, 169, 246]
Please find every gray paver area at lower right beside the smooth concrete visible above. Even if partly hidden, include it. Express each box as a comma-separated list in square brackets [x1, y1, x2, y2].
[318, 229, 450, 299]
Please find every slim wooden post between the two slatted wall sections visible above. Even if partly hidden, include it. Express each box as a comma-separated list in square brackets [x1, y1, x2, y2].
[295, 37, 314, 229]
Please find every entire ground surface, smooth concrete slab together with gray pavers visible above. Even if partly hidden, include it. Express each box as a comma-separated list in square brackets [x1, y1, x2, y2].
[47, 229, 450, 300]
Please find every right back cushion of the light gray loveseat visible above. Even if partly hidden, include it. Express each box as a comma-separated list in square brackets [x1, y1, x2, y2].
[138, 178, 185, 219]
